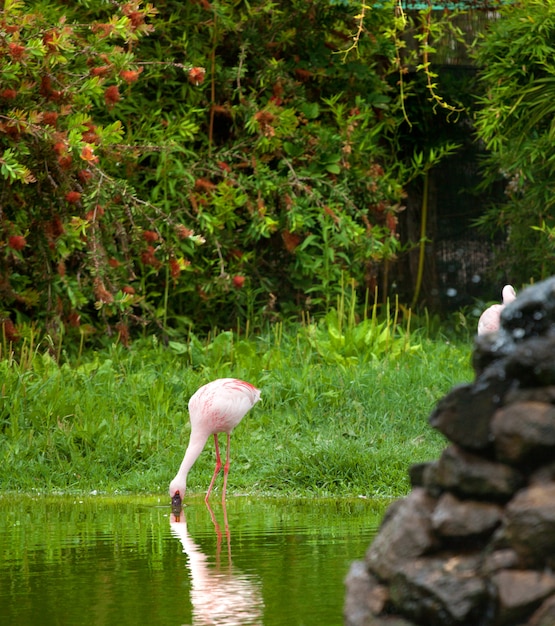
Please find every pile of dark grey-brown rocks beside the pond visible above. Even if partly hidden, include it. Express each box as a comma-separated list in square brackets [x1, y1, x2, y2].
[344, 277, 555, 626]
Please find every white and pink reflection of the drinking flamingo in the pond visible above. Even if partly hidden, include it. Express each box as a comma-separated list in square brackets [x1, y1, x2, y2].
[170, 503, 264, 626]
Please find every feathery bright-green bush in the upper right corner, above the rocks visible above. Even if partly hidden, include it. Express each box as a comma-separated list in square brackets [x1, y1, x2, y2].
[476, 0, 555, 282]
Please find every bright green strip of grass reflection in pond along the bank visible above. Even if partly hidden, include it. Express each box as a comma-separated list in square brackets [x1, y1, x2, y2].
[0, 494, 388, 563]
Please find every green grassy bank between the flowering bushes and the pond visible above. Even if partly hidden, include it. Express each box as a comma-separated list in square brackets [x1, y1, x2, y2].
[0, 312, 472, 497]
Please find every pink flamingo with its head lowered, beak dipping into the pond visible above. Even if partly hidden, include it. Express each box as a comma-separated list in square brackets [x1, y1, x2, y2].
[170, 378, 260, 508]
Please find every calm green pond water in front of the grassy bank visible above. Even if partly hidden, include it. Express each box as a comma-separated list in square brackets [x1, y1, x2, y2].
[0, 495, 387, 626]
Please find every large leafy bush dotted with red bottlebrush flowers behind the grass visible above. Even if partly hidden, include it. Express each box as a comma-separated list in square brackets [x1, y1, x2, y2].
[0, 0, 466, 343]
